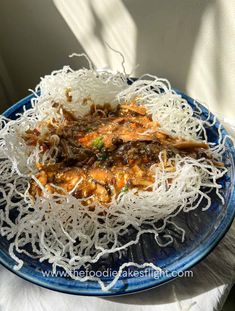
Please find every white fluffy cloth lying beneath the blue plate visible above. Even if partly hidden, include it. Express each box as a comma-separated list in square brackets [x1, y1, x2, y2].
[0, 222, 235, 311]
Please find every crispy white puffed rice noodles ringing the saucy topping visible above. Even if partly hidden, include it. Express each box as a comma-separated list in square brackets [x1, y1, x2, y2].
[0, 66, 227, 290]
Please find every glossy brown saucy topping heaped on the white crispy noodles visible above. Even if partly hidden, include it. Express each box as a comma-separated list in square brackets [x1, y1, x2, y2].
[24, 101, 211, 206]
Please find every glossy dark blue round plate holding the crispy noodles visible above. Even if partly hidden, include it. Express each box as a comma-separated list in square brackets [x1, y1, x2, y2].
[0, 91, 235, 296]
